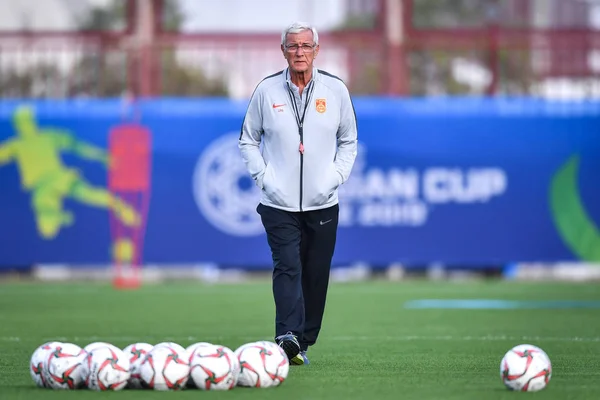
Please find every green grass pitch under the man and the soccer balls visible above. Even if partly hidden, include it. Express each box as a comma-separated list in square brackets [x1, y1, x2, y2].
[0, 281, 600, 400]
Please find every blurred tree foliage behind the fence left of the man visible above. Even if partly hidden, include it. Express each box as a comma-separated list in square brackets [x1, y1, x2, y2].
[0, 0, 228, 98]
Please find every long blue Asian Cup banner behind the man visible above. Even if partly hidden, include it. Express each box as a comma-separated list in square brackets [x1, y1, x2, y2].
[0, 98, 600, 268]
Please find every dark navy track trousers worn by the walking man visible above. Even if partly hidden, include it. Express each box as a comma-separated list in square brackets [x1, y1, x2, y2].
[257, 204, 339, 350]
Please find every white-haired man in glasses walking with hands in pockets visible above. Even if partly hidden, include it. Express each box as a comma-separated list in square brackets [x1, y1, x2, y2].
[239, 23, 357, 365]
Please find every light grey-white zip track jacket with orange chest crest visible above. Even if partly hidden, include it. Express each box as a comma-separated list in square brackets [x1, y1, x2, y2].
[239, 68, 357, 211]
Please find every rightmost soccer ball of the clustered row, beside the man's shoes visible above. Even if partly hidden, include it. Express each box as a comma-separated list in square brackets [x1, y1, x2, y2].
[235, 341, 290, 388]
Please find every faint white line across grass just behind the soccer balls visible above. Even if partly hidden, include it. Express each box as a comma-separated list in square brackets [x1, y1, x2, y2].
[0, 335, 600, 343]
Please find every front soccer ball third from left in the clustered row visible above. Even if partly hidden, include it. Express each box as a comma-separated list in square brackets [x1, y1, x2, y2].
[84, 346, 129, 391]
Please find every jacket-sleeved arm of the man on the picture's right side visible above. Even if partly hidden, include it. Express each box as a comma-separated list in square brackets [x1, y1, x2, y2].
[335, 85, 358, 185]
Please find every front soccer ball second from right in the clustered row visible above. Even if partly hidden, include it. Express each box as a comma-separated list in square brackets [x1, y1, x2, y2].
[190, 345, 240, 390]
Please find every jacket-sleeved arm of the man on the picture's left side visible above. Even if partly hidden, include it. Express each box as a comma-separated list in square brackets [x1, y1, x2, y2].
[238, 86, 265, 189]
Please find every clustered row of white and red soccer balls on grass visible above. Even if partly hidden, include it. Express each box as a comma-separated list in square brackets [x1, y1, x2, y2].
[30, 341, 289, 391]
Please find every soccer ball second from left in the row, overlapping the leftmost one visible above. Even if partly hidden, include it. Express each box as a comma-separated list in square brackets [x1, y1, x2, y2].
[42, 343, 86, 390]
